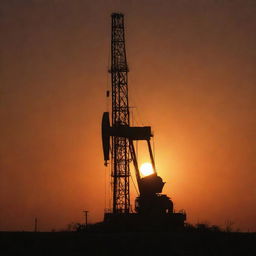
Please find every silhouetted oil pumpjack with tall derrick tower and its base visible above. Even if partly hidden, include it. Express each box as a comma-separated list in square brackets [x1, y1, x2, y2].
[102, 13, 186, 228]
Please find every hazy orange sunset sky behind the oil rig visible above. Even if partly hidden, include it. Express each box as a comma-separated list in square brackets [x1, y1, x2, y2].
[0, 0, 256, 231]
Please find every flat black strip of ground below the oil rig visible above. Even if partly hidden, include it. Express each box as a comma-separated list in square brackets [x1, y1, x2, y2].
[0, 231, 256, 256]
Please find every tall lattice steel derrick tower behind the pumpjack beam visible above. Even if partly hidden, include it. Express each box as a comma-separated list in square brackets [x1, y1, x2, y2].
[110, 13, 130, 213]
